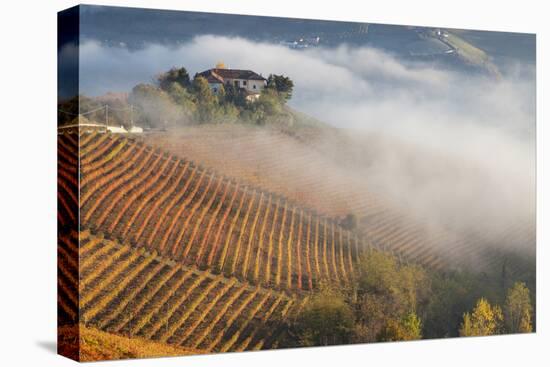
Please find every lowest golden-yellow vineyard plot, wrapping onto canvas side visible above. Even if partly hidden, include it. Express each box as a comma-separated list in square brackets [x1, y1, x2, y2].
[59, 231, 305, 360]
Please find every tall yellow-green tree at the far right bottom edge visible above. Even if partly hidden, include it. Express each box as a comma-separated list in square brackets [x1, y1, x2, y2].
[504, 282, 533, 333]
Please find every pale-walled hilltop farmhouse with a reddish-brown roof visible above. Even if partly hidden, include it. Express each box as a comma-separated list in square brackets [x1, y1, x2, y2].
[198, 68, 267, 101]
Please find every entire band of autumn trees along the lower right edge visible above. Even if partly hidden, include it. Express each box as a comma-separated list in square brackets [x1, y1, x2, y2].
[284, 250, 534, 346]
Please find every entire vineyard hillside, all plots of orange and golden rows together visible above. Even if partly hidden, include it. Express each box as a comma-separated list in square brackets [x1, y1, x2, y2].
[58, 128, 534, 360]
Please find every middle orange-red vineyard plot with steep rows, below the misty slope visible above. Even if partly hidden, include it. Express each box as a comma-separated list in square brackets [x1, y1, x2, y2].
[80, 134, 366, 290]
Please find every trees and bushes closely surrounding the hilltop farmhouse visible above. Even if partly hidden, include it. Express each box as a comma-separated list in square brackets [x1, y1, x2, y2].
[128, 67, 294, 127]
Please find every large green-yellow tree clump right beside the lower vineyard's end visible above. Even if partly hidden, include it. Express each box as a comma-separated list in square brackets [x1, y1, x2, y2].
[288, 250, 429, 346]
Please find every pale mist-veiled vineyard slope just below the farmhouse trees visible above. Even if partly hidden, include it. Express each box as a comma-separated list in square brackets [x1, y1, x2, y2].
[143, 126, 458, 268]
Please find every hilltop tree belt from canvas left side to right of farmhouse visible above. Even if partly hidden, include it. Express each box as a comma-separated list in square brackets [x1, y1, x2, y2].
[58, 67, 294, 128]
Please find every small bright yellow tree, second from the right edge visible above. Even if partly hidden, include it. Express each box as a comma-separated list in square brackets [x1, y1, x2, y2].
[459, 298, 503, 336]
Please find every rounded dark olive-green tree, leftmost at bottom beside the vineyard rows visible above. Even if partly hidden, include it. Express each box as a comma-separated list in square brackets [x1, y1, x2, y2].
[296, 290, 354, 346]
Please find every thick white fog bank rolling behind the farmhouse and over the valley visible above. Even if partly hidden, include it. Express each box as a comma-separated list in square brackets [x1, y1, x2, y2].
[74, 36, 536, 264]
